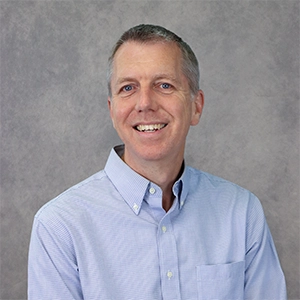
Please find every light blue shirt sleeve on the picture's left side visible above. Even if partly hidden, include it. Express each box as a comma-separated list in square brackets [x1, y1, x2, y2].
[28, 218, 83, 300]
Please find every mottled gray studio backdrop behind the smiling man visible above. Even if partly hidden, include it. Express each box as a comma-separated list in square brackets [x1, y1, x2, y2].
[0, 0, 300, 300]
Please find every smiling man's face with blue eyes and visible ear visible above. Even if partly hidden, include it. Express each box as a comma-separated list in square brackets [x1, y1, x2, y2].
[108, 41, 203, 166]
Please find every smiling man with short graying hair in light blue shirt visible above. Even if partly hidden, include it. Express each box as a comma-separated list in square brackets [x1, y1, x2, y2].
[28, 25, 286, 300]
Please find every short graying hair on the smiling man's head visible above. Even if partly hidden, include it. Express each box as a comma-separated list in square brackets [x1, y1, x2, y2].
[107, 24, 200, 96]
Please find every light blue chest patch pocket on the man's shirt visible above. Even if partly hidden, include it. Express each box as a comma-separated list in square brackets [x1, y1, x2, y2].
[197, 261, 245, 300]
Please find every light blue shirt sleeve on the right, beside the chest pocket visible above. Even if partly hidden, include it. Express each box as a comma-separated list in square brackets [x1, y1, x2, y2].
[245, 195, 287, 300]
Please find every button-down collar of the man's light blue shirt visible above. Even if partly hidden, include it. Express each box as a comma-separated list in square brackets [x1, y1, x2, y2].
[104, 145, 189, 214]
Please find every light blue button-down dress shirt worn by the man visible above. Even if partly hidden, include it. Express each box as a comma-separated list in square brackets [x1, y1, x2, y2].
[28, 147, 286, 300]
